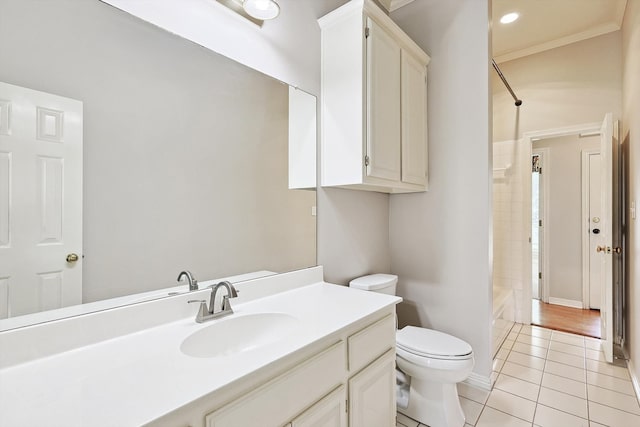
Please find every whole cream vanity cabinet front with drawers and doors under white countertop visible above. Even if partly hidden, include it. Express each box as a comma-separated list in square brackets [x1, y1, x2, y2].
[205, 313, 396, 427]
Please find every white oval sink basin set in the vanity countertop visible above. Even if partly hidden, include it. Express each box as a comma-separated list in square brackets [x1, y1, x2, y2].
[180, 313, 298, 357]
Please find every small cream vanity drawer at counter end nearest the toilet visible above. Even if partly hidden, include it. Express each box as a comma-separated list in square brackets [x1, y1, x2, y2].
[349, 314, 396, 373]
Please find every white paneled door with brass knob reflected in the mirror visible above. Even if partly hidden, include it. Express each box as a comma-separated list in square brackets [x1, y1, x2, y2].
[0, 82, 82, 318]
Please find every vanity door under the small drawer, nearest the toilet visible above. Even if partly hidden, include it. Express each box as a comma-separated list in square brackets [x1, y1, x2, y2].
[349, 350, 396, 427]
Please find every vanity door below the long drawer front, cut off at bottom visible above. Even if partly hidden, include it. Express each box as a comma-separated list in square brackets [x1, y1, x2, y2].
[291, 386, 347, 427]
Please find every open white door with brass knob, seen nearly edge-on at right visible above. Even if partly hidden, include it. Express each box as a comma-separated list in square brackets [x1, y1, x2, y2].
[596, 113, 613, 363]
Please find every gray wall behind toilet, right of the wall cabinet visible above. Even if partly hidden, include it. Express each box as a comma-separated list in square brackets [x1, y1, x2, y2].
[390, 0, 492, 379]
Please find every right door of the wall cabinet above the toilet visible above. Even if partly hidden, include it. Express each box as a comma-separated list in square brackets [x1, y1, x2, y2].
[401, 50, 427, 185]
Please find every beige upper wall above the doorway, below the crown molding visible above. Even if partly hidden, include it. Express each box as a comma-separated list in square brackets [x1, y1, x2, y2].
[492, 31, 622, 142]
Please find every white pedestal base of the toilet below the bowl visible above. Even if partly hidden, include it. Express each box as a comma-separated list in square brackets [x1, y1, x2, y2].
[398, 378, 465, 427]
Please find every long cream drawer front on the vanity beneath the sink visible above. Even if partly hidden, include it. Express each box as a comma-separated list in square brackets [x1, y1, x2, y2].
[205, 341, 345, 427]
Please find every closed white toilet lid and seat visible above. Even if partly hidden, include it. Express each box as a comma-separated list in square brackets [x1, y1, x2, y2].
[396, 326, 473, 360]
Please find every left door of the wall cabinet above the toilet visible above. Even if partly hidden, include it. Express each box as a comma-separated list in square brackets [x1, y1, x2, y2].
[366, 19, 400, 182]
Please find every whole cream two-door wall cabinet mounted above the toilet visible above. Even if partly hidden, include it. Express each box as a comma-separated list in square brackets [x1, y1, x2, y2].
[319, 0, 429, 193]
